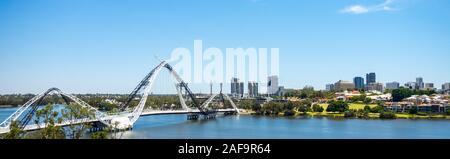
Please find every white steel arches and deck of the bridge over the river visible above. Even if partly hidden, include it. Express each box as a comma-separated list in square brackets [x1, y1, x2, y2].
[0, 61, 239, 134]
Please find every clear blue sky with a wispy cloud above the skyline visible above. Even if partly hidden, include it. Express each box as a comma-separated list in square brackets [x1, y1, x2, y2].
[0, 0, 450, 94]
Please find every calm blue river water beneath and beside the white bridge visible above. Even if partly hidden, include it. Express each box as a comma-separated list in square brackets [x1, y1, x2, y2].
[0, 108, 450, 139]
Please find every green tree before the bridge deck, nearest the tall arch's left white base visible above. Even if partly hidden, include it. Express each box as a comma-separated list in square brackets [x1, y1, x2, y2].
[62, 104, 95, 139]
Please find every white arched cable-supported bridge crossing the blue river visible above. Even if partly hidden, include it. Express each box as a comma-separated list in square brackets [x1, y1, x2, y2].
[0, 61, 239, 134]
